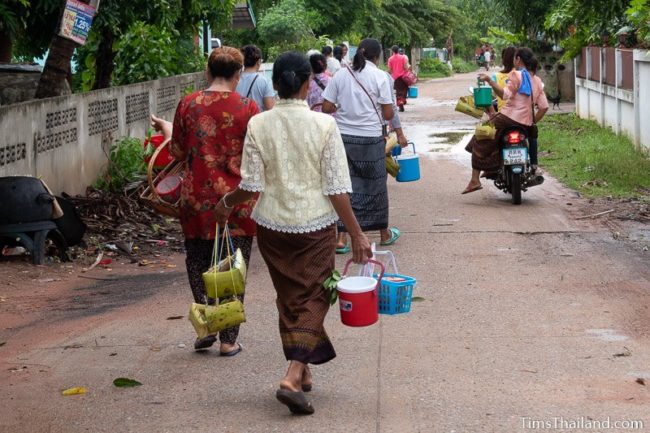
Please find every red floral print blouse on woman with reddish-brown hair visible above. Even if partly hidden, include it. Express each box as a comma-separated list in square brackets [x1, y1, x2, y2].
[171, 90, 259, 239]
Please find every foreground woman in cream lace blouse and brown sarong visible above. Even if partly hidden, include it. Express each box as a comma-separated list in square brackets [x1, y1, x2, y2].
[217, 53, 372, 414]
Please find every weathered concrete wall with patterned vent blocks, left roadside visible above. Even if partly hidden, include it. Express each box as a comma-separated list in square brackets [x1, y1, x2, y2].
[0, 73, 207, 194]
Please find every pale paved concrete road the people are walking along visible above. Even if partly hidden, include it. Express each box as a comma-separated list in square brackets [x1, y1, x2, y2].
[0, 75, 650, 433]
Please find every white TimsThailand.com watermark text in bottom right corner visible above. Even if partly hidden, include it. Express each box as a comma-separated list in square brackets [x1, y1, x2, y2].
[521, 416, 645, 432]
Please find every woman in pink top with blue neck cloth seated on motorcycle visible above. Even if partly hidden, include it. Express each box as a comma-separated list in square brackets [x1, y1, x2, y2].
[461, 48, 549, 194]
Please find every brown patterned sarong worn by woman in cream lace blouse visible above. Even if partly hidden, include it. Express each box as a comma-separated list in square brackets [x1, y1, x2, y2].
[257, 225, 336, 364]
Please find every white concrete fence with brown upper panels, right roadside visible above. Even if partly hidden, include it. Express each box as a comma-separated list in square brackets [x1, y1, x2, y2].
[575, 47, 650, 149]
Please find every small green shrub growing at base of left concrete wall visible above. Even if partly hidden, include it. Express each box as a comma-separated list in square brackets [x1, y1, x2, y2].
[94, 137, 146, 192]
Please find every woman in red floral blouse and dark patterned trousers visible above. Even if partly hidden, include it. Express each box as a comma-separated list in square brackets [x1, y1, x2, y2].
[171, 47, 259, 356]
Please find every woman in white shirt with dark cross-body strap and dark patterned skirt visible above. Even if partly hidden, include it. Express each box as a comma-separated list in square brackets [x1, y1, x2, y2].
[323, 39, 400, 254]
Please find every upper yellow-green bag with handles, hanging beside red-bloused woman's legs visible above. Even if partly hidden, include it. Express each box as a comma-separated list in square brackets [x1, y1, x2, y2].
[203, 226, 246, 299]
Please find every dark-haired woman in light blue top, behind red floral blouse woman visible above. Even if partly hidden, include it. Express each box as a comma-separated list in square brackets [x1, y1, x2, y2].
[237, 45, 275, 112]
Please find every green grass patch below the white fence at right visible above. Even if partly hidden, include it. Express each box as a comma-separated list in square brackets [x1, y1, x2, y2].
[539, 114, 650, 198]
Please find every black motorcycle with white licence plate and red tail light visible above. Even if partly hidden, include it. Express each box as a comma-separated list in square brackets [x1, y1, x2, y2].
[492, 127, 544, 204]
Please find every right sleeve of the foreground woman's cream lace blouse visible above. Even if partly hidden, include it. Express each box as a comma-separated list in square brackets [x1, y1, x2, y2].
[320, 122, 352, 195]
